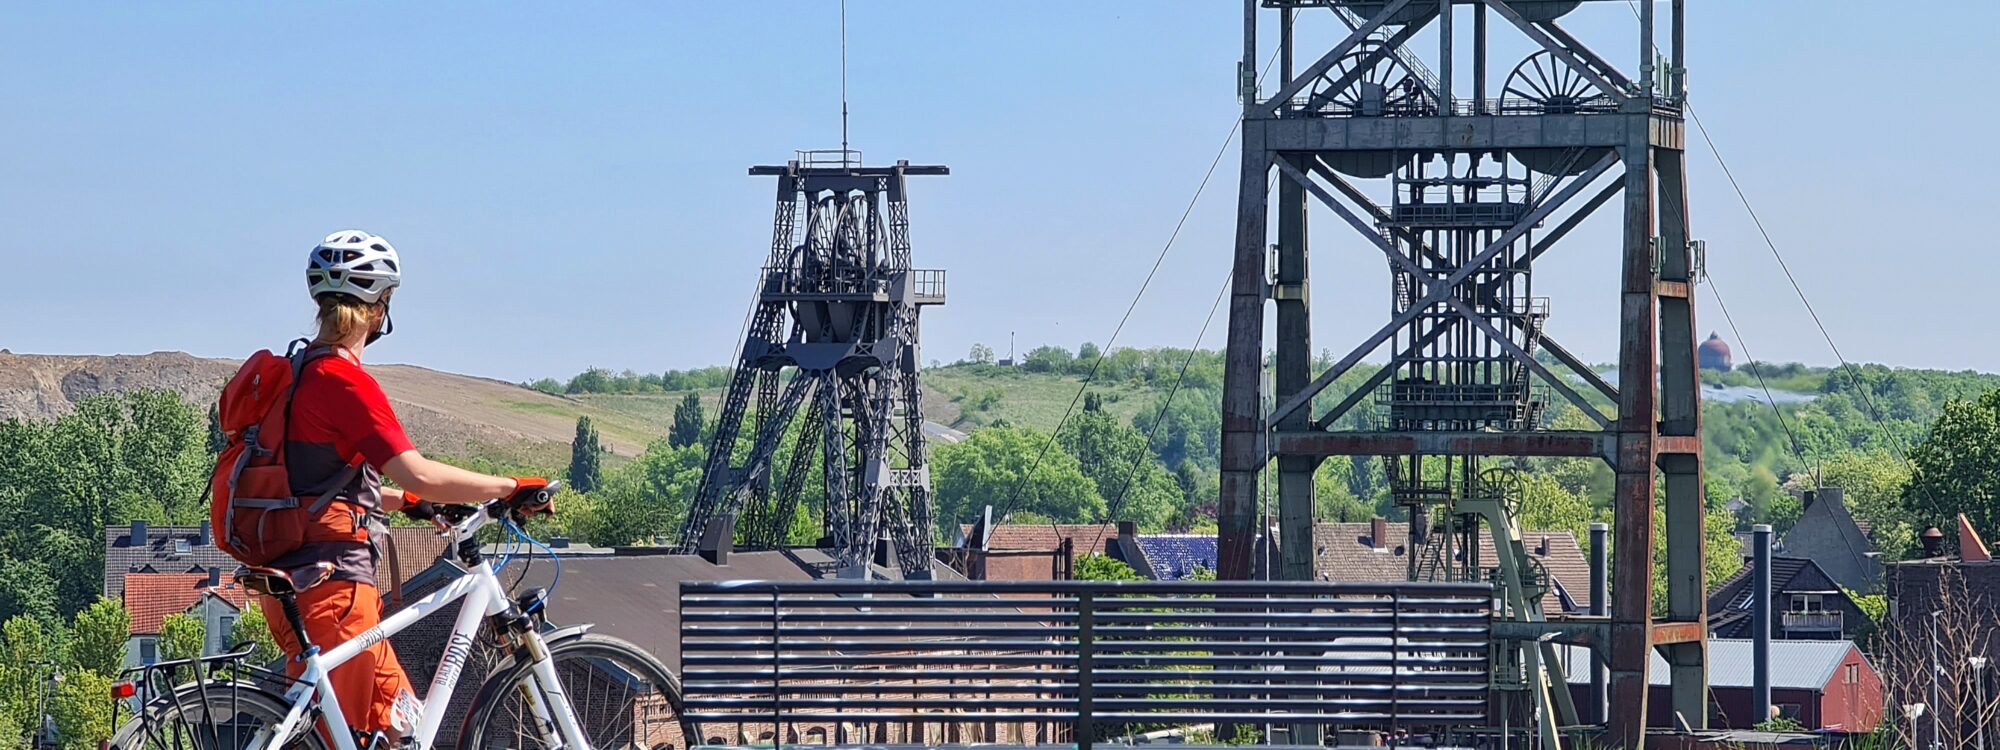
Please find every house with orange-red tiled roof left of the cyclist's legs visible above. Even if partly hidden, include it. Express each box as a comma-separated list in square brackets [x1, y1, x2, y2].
[120, 568, 250, 668]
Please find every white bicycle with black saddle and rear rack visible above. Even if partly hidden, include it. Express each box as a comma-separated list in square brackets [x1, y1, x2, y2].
[110, 486, 692, 750]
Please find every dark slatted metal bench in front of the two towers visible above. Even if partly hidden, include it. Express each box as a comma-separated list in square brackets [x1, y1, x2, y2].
[680, 580, 1494, 748]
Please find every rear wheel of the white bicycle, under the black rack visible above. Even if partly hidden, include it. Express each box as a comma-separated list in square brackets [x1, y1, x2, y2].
[110, 682, 328, 750]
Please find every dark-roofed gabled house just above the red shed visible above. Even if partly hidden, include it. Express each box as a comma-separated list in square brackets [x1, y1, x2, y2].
[1708, 556, 1868, 640]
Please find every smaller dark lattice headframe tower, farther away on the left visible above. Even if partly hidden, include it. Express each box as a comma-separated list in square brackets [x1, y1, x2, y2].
[680, 150, 948, 578]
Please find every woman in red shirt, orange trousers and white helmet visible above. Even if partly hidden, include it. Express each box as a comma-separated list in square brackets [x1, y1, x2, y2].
[266, 230, 550, 740]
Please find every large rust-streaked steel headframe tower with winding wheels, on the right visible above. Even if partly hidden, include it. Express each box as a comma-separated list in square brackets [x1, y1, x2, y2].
[1220, 0, 1706, 746]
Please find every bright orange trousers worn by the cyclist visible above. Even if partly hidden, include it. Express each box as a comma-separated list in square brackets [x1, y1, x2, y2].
[264, 580, 410, 732]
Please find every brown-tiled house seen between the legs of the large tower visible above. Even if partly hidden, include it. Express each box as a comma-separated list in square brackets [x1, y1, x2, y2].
[1312, 518, 1590, 614]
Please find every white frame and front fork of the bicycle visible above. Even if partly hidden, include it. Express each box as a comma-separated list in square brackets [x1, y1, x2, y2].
[250, 512, 590, 750]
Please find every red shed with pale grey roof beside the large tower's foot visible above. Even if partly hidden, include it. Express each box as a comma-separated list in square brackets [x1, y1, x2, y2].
[1560, 638, 1884, 734]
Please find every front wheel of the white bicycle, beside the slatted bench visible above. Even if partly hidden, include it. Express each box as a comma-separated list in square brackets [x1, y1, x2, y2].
[458, 634, 688, 750]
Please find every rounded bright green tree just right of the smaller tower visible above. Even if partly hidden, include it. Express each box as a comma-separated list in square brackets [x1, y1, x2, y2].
[930, 428, 1106, 522]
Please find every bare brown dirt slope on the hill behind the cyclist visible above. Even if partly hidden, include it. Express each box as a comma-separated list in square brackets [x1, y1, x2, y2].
[0, 352, 666, 464]
